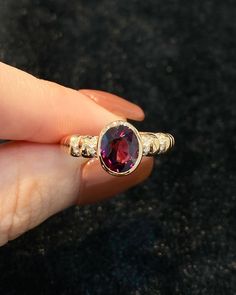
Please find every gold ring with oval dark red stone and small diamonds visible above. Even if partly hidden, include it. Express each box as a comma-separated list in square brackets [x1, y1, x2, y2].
[61, 121, 175, 176]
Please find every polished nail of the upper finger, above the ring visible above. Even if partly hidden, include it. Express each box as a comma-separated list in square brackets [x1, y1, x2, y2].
[79, 89, 145, 121]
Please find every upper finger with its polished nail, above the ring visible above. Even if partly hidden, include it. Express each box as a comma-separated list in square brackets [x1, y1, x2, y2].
[0, 63, 143, 143]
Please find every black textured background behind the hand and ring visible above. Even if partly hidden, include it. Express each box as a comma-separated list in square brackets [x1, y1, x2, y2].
[0, 0, 236, 295]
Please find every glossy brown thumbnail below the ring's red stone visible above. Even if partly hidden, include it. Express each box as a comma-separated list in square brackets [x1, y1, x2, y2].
[78, 157, 153, 205]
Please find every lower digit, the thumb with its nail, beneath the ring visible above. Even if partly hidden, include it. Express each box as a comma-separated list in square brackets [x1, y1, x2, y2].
[0, 143, 152, 245]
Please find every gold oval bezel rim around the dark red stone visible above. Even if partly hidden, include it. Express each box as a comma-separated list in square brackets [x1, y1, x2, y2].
[97, 120, 143, 176]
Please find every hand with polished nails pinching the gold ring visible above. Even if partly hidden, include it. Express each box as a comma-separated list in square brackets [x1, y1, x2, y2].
[0, 63, 153, 245]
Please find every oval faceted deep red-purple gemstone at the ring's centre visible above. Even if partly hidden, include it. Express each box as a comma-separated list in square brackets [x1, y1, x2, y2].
[101, 125, 139, 173]
